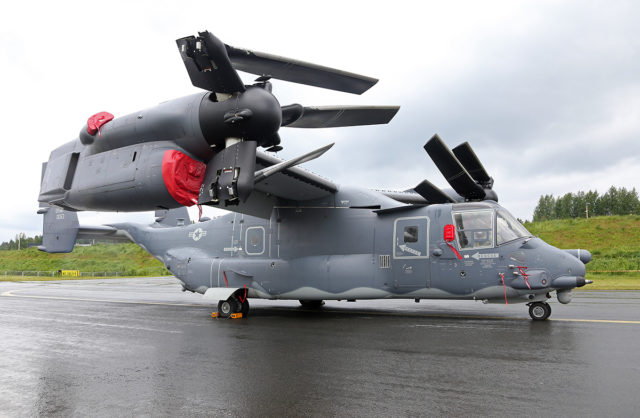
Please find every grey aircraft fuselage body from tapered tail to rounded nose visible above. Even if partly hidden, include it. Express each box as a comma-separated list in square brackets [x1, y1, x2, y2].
[113, 189, 585, 303]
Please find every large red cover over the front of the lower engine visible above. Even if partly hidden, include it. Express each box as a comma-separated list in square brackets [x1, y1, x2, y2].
[162, 150, 207, 206]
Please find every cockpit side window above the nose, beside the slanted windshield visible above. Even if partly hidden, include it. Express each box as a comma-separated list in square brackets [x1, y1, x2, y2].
[453, 210, 493, 250]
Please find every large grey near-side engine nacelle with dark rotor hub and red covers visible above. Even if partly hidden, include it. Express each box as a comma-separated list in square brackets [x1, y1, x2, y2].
[38, 87, 282, 212]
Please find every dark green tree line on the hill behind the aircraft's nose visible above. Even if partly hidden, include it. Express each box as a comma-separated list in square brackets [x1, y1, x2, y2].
[533, 186, 640, 222]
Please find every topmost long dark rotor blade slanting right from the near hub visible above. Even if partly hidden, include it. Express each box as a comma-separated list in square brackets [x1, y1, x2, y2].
[225, 45, 378, 94]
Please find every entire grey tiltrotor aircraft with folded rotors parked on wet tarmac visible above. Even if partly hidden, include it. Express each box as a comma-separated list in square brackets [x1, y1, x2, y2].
[38, 32, 591, 320]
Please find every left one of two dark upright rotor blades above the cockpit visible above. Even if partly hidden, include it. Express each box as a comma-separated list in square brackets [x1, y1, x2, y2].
[424, 134, 485, 199]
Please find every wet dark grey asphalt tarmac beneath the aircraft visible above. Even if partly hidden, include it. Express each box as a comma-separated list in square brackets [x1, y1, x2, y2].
[0, 278, 640, 416]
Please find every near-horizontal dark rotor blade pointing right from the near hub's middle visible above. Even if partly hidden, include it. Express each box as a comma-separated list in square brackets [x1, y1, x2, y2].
[282, 105, 400, 128]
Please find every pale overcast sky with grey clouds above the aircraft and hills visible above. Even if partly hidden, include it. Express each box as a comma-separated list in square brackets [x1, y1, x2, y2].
[0, 0, 640, 241]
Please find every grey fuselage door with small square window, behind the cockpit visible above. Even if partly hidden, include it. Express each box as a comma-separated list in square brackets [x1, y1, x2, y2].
[391, 216, 430, 293]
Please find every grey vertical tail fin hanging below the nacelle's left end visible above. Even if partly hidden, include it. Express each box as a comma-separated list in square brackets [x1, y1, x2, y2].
[38, 205, 79, 253]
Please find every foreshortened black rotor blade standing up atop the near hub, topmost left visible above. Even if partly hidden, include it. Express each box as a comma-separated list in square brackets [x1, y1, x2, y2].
[176, 31, 245, 94]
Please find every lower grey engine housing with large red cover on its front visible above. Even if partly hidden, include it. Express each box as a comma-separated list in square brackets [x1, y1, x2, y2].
[39, 143, 206, 212]
